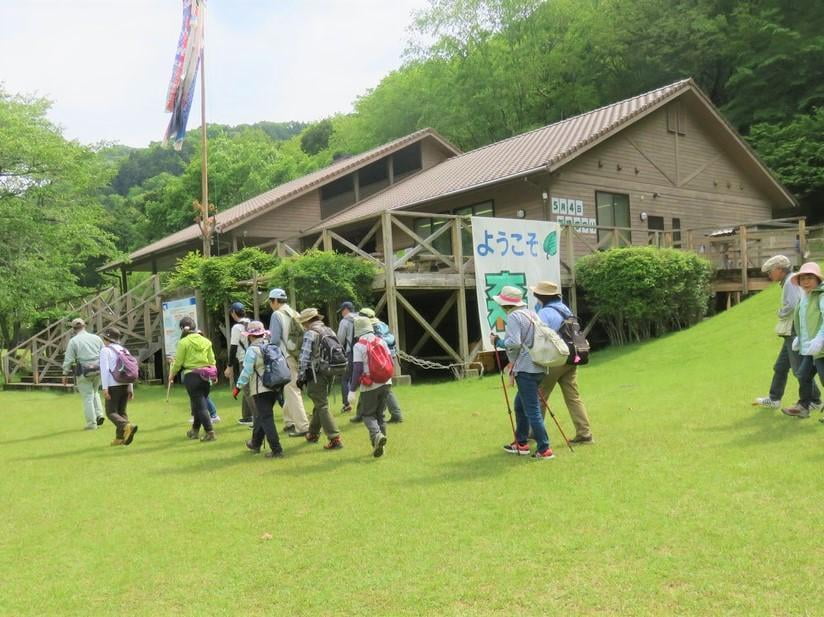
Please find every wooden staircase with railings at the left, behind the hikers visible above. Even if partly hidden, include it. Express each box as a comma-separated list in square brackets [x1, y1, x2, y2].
[3, 275, 163, 390]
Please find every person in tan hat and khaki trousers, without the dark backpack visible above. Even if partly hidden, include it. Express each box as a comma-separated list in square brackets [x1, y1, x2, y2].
[529, 281, 593, 444]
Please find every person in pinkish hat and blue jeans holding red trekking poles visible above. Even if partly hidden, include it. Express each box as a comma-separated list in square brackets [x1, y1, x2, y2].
[489, 285, 555, 460]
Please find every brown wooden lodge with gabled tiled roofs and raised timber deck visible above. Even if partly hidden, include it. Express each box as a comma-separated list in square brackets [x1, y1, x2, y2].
[103, 79, 805, 376]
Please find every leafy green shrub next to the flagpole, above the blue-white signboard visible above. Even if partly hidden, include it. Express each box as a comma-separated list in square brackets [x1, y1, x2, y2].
[169, 248, 279, 318]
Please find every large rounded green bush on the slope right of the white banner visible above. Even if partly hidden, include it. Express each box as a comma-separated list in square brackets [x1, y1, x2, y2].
[575, 247, 713, 345]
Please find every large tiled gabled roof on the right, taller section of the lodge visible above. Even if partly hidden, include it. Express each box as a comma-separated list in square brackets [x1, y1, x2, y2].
[310, 79, 795, 231]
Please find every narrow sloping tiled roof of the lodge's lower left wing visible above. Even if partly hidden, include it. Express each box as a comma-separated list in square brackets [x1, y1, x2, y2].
[118, 128, 460, 269]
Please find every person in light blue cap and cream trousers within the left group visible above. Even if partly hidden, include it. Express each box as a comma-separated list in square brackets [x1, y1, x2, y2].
[269, 287, 309, 437]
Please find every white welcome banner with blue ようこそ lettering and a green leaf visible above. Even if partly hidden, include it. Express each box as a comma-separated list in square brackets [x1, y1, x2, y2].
[472, 216, 561, 351]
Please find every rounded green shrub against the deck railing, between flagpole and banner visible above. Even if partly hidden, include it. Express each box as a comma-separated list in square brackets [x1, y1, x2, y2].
[269, 250, 377, 308]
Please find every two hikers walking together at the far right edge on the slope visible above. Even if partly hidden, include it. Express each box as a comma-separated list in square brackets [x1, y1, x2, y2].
[753, 255, 824, 422]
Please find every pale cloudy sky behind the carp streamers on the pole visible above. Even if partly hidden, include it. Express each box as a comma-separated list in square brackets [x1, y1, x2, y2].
[0, 0, 428, 147]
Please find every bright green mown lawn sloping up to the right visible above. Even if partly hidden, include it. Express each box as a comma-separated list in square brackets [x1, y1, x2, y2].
[0, 289, 824, 616]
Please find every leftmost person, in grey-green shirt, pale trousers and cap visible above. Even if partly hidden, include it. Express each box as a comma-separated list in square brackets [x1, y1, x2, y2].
[63, 317, 104, 431]
